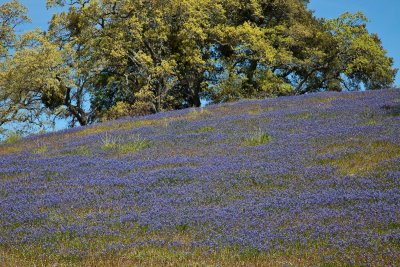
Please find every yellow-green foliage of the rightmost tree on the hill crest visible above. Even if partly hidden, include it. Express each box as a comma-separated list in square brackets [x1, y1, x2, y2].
[324, 13, 397, 90]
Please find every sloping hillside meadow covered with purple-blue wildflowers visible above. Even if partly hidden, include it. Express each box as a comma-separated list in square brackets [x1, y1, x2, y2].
[0, 90, 400, 266]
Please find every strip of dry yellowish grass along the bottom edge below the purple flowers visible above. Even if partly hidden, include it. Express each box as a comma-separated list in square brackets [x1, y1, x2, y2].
[0, 245, 400, 267]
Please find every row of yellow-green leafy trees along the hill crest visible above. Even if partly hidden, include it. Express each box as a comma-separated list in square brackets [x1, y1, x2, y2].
[0, 0, 397, 138]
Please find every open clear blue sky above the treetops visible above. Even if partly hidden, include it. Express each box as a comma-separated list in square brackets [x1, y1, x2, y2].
[0, 0, 400, 87]
